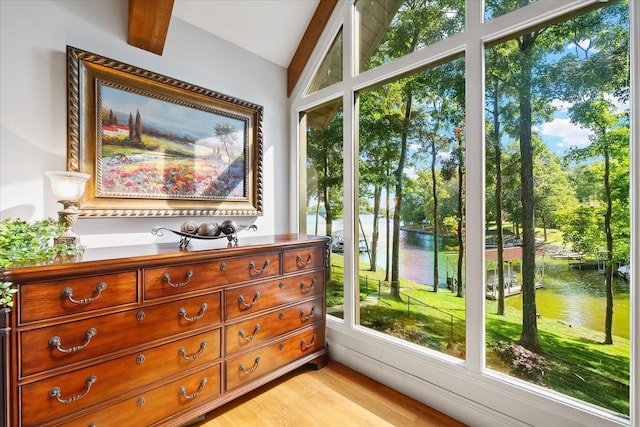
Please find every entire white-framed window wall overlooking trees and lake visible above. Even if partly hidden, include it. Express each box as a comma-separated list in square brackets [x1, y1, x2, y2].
[292, 0, 640, 427]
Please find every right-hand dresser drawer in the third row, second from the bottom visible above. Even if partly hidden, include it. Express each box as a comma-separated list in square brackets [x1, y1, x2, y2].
[225, 298, 323, 355]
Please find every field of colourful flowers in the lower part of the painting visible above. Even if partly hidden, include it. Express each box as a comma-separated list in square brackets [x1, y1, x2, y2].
[100, 135, 244, 200]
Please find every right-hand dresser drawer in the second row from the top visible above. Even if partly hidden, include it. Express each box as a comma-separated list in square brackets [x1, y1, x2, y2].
[225, 271, 324, 320]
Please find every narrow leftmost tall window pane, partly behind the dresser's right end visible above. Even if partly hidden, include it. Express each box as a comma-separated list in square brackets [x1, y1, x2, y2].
[301, 99, 344, 319]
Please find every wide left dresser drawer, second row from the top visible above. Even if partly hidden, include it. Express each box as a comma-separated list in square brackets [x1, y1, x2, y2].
[19, 292, 221, 376]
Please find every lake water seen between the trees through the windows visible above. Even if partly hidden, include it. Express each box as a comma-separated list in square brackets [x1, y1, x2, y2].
[307, 215, 631, 338]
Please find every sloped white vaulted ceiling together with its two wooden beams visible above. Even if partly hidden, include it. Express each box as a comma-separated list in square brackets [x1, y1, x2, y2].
[127, 0, 338, 95]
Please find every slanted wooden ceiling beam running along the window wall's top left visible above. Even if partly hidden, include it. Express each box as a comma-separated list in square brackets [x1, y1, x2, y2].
[287, 0, 338, 96]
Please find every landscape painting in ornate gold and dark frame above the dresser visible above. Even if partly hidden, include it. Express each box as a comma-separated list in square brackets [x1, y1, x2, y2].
[67, 47, 262, 217]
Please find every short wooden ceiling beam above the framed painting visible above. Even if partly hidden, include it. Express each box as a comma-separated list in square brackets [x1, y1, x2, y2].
[127, 0, 174, 55]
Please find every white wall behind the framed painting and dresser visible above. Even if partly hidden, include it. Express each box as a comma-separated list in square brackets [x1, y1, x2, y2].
[0, 0, 289, 247]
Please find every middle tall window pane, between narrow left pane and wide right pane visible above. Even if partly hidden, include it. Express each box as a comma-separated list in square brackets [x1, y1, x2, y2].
[358, 59, 465, 358]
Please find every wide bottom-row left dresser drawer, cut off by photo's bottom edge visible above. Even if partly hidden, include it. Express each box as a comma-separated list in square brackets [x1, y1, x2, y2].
[55, 365, 221, 427]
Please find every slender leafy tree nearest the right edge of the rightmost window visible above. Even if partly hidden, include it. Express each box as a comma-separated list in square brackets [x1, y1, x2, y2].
[552, 1, 629, 344]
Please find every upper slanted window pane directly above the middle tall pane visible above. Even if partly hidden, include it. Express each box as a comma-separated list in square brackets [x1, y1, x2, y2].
[355, 0, 464, 72]
